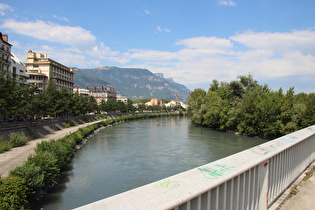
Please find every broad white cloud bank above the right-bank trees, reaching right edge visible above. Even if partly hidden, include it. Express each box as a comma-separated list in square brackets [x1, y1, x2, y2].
[119, 30, 315, 92]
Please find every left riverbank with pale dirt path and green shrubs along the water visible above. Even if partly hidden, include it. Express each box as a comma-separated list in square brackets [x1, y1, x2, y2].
[0, 113, 183, 209]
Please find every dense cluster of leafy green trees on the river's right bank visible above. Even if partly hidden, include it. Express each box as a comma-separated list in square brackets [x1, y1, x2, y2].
[187, 75, 315, 139]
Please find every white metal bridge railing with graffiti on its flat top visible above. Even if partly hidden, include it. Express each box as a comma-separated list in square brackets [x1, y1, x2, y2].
[78, 125, 315, 210]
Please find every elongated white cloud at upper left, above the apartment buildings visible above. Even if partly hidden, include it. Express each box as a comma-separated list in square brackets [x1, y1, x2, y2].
[1, 19, 95, 48]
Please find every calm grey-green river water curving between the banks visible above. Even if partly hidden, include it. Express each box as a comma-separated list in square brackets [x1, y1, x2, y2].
[33, 117, 265, 209]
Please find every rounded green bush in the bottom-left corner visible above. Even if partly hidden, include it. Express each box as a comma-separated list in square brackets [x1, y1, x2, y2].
[0, 176, 28, 209]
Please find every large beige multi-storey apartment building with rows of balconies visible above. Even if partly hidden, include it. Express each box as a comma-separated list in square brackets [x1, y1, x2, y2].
[26, 50, 74, 92]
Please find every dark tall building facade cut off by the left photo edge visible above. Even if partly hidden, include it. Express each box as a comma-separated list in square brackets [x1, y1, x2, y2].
[0, 32, 12, 73]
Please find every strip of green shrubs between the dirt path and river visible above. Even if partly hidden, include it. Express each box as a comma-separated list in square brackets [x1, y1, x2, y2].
[0, 113, 182, 209]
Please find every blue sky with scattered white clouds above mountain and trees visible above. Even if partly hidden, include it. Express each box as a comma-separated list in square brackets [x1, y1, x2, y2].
[0, 0, 315, 93]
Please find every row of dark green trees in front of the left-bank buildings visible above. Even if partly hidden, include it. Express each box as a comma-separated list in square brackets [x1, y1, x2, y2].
[0, 73, 180, 119]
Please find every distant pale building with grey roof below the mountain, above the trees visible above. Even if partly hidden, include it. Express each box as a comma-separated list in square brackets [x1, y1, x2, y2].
[86, 86, 117, 104]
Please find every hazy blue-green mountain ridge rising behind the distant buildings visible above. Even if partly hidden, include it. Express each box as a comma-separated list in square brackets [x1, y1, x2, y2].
[74, 66, 190, 101]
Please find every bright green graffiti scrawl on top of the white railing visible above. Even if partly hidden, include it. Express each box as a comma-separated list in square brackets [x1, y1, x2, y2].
[198, 164, 235, 179]
